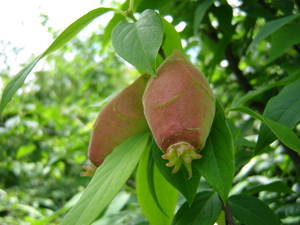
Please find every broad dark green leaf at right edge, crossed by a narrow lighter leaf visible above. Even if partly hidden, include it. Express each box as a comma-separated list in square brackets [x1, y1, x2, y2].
[256, 79, 300, 151]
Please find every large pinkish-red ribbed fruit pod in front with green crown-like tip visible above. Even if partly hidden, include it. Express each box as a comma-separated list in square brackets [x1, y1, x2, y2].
[143, 51, 215, 177]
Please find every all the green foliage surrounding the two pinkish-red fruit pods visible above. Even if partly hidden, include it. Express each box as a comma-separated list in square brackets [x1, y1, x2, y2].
[0, 0, 300, 225]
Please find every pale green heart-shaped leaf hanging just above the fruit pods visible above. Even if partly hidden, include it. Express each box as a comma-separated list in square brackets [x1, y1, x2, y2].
[111, 9, 163, 76]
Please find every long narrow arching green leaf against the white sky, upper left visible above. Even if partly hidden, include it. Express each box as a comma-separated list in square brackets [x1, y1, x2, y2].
[0, 7, 114, 114]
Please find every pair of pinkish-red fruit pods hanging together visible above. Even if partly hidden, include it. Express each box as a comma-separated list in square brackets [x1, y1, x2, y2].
[89, 51, 215, 177]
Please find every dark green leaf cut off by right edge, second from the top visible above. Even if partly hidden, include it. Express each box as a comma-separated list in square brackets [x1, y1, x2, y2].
[267, 23, 300, 63]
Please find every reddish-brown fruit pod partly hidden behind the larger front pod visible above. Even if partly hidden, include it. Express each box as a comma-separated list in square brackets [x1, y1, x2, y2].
[88, 75, 148, 166]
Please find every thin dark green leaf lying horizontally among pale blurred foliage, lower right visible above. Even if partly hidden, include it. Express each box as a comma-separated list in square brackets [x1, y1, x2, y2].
[243, 180, 292, 194]
